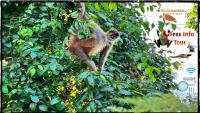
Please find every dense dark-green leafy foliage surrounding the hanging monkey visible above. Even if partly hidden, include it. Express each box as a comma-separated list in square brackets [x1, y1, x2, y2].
[2, 2, 180, 112]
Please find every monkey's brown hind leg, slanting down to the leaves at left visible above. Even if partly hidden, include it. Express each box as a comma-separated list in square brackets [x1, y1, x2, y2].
[73, 48, 97, 71]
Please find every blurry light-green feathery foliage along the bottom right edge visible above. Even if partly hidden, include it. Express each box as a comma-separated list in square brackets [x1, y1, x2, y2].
[109, 94, 197, 112]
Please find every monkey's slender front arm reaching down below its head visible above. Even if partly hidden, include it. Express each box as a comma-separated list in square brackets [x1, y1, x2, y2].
[99, 45, 113, 71]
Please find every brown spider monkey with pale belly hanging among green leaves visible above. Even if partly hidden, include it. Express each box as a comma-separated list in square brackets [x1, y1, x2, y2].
[67, 3, 120, 72]
